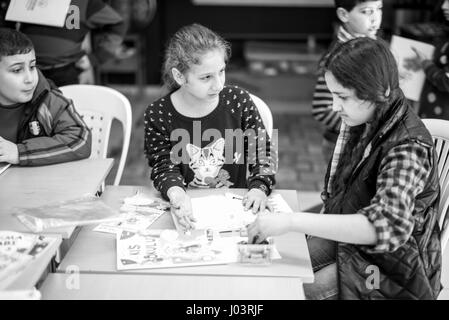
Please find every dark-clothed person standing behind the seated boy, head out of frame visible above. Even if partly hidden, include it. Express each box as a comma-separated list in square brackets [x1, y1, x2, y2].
[0, 0, 126, 87]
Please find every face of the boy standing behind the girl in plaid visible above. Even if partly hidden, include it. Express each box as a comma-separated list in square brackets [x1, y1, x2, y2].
[340, 0, 382, 38]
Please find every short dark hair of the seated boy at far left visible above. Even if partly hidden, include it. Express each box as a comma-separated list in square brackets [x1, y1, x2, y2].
[0, 28, 34, 60]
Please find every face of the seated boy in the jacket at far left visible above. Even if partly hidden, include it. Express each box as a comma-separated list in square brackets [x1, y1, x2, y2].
[0, 50, 38, 105]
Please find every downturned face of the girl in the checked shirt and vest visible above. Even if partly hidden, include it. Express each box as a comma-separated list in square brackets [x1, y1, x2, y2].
[325, 71, 376, 127]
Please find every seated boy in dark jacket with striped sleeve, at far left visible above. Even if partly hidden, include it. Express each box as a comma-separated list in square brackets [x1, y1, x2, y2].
[0, 28, 91, 166]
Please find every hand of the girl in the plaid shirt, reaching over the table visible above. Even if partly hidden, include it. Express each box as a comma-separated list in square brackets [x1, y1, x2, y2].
[247, 212, 292, 243]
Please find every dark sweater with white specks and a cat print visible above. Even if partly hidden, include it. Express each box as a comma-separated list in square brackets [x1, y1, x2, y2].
[145, 86, 277, 199]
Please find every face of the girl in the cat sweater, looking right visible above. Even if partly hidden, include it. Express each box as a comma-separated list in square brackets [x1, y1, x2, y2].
[181, 50, 226, 101]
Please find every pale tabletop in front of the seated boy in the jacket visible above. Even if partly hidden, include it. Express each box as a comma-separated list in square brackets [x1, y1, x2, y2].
[0, 159, 114, 239]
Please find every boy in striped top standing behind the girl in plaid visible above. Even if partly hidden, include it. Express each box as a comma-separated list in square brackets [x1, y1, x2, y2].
[312, 0, 383, 163]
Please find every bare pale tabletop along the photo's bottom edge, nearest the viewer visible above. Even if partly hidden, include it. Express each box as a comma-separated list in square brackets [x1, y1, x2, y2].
[40, 273, 304, 300]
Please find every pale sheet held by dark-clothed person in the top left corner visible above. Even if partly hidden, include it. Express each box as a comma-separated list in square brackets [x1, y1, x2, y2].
[5, 0, 70, 27]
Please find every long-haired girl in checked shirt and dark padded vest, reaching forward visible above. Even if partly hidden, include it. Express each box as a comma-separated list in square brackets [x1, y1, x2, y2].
[248, 37, 441, 299]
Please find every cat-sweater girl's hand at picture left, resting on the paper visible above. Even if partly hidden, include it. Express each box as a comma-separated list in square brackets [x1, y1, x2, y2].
[167, 187, 196, 231]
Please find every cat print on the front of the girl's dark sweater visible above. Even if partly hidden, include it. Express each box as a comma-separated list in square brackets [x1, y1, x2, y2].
[186, 138, 233, 188]
